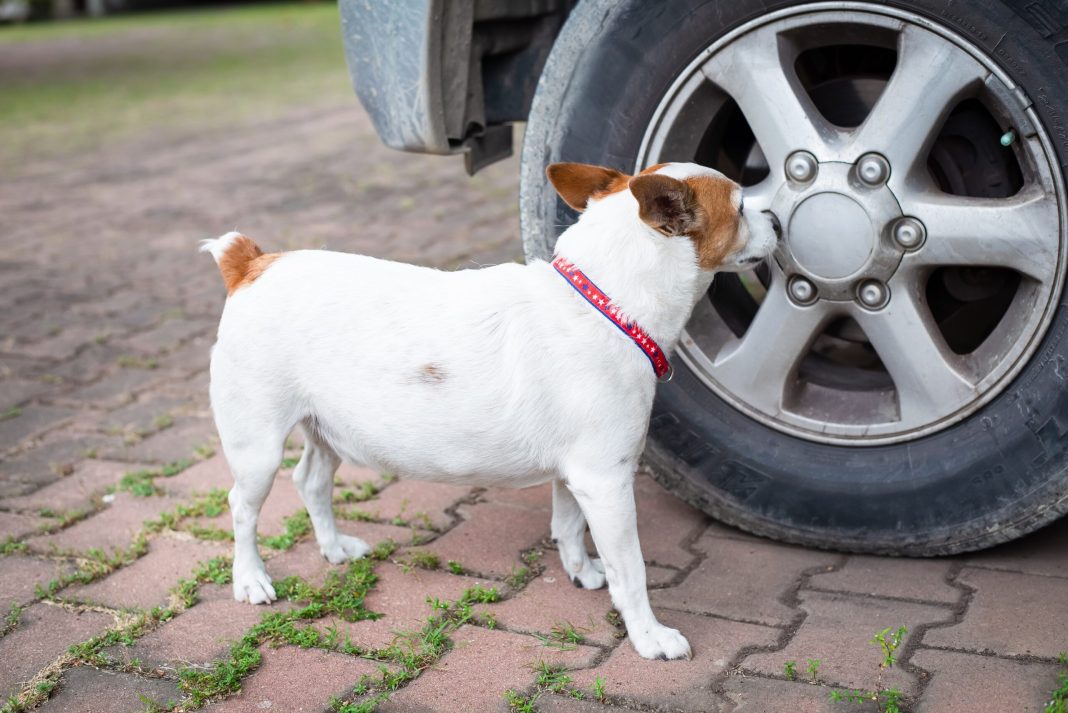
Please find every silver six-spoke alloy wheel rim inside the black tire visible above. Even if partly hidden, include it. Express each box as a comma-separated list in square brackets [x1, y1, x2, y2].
[635, 2, 1066, 445]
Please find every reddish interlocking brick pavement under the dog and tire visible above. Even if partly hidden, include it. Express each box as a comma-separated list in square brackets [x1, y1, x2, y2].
[0, 80, 1068, 713]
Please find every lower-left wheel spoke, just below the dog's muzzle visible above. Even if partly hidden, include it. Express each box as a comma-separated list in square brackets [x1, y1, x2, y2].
[712, 270, 830, 411]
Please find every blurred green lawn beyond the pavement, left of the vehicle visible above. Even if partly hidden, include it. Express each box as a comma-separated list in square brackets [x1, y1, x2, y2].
[0, 2, 355, 173]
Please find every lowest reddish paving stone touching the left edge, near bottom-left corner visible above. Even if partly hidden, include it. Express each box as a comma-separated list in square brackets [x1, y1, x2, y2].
[0, 604, 114, 698]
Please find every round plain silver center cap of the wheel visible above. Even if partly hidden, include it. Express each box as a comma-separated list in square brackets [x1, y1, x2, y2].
[787, 193, 875, 280]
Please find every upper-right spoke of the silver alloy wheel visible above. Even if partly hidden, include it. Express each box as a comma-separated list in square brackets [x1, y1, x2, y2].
[842, 26, 987, 181]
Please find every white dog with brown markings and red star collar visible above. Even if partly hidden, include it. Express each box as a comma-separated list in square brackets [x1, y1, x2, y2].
[202, 163, 778, 659]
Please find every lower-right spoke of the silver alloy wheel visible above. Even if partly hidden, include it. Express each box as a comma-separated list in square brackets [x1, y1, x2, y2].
[853, 285, 976, 426]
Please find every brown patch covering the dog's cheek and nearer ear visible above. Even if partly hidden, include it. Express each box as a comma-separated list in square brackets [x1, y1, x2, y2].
[630, 172, 739, 270]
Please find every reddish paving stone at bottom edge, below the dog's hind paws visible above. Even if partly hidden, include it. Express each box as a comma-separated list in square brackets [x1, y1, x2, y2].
[204, 646, 378, 713]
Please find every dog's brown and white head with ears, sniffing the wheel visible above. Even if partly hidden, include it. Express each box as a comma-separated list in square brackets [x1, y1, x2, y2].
[546, 163, 779, 272]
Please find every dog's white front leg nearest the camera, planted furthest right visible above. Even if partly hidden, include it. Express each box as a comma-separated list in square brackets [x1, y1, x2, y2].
[554, 468, 691, 659]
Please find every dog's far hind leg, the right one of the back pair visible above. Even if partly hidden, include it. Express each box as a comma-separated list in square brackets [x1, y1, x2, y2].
[293, 424, 371, 565]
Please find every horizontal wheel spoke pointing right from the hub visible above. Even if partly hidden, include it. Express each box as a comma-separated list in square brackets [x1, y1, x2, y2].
[902, 190, 1058, 283]
